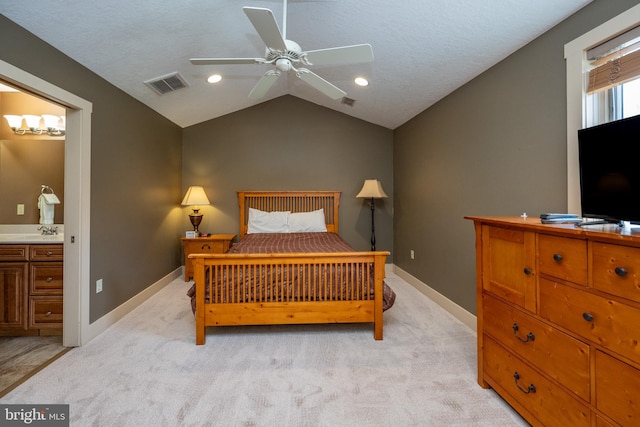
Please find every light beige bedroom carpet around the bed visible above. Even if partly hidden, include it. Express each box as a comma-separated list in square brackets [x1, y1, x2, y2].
[0, 274, 527, 427]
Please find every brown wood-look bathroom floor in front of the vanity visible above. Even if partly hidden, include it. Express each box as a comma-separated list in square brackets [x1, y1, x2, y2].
[0, 336, 67, 397]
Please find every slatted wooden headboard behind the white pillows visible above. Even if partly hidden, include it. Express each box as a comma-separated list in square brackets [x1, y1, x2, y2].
[238, 191, 340, 239]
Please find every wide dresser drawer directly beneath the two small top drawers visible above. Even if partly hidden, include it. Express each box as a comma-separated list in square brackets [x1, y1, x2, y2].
[540, 278, 640, 363]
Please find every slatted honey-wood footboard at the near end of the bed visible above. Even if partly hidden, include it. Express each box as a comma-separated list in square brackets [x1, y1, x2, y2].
[189, 251, 389, 345]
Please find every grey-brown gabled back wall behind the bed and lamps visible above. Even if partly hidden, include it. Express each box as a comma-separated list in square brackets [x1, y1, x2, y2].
[183, 96, 393, 262]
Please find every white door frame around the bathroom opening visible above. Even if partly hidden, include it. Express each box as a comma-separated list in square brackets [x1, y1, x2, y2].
[0, 60, 93, 347]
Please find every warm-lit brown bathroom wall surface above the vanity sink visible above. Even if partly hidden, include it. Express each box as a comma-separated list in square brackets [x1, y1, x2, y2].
[0, 88, 65, 224]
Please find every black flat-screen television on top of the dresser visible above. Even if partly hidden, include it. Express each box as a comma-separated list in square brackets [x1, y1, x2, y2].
[578, 115, 640, 223]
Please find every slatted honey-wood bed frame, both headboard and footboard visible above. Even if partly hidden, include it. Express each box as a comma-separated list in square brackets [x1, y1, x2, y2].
[189, 191, 389, 345]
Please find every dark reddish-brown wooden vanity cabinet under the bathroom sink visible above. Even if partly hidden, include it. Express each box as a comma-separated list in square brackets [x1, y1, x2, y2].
[0, 243, 63, 336]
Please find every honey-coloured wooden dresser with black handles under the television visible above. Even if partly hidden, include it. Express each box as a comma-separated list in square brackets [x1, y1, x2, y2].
[467, 217, 640, 427]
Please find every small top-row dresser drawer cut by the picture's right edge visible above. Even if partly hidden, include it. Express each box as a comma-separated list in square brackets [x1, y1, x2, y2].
[591, 242, 640, 302]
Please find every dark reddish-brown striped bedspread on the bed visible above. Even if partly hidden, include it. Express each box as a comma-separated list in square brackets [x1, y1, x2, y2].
[187, 232, 396, 313]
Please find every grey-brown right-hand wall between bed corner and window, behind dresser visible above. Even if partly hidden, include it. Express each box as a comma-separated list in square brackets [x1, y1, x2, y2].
[393, 0, 639, 313]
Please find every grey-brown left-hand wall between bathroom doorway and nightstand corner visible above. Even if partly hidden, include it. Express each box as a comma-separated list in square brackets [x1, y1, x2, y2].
[0, 16, 182, 321]
